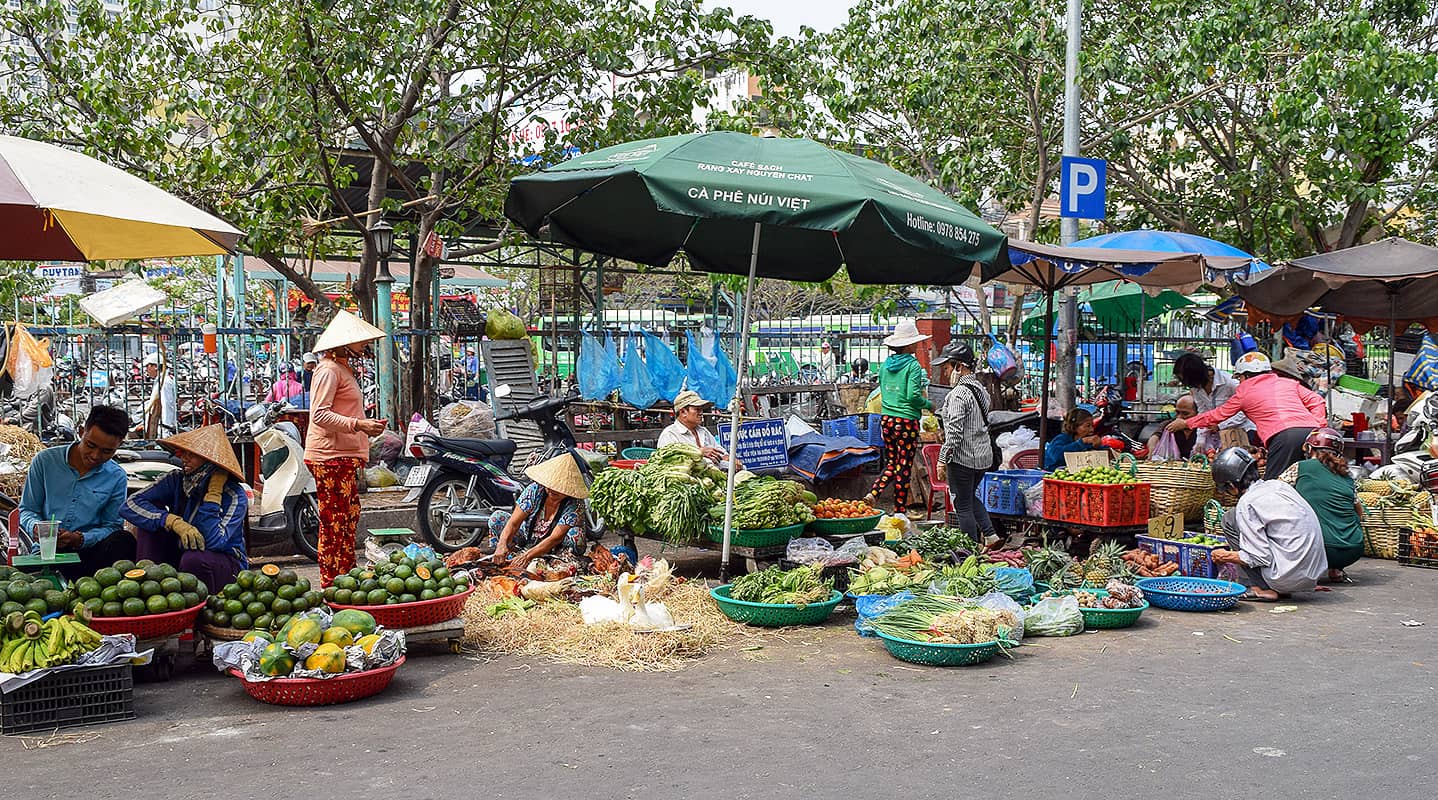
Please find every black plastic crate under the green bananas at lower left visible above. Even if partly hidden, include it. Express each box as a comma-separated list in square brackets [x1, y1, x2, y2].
[0, 663, 135, 735]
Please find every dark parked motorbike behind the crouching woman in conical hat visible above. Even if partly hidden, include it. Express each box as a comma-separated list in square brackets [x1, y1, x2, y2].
[406, 386, 607, 553]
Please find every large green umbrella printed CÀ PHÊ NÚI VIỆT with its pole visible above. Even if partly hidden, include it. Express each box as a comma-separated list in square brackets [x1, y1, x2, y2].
[505, 131, 1007, 571]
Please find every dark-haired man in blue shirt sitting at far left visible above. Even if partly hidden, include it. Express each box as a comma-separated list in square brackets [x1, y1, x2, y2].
[20, 406, 135, 578]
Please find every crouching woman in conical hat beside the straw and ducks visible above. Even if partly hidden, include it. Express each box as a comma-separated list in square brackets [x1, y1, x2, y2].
[489, 453, 590, 570]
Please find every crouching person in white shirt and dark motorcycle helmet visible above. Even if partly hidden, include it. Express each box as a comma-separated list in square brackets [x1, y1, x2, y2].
[1209, 447, 1329, 603]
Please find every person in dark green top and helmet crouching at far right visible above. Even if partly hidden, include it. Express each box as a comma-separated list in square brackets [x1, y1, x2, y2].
[1283, 427, 1363, 583]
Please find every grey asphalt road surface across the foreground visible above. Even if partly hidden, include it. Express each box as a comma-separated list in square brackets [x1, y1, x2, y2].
[0, 560, 1438, 800]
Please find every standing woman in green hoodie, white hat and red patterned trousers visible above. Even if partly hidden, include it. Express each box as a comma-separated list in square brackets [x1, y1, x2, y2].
[864, 319, 933, 514]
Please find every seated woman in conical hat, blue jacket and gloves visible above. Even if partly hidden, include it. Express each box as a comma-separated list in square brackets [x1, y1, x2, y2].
[119, 424, 250, 591]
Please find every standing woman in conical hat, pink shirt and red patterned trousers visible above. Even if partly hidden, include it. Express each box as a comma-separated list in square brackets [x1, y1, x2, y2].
[305, 311, 385, 586]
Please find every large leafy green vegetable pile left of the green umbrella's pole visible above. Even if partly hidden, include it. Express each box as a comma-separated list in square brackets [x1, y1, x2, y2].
[590, 445, 726, 544]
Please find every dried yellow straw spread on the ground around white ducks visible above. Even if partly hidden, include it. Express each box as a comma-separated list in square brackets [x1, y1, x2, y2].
[464, 583, 745, 672]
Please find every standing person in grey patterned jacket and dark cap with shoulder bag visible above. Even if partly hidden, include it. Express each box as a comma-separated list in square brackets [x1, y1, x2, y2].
[933, 341, 995, 541]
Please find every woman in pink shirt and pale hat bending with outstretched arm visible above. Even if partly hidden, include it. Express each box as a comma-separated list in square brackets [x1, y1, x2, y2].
[1168, 353, 1329, 481]
